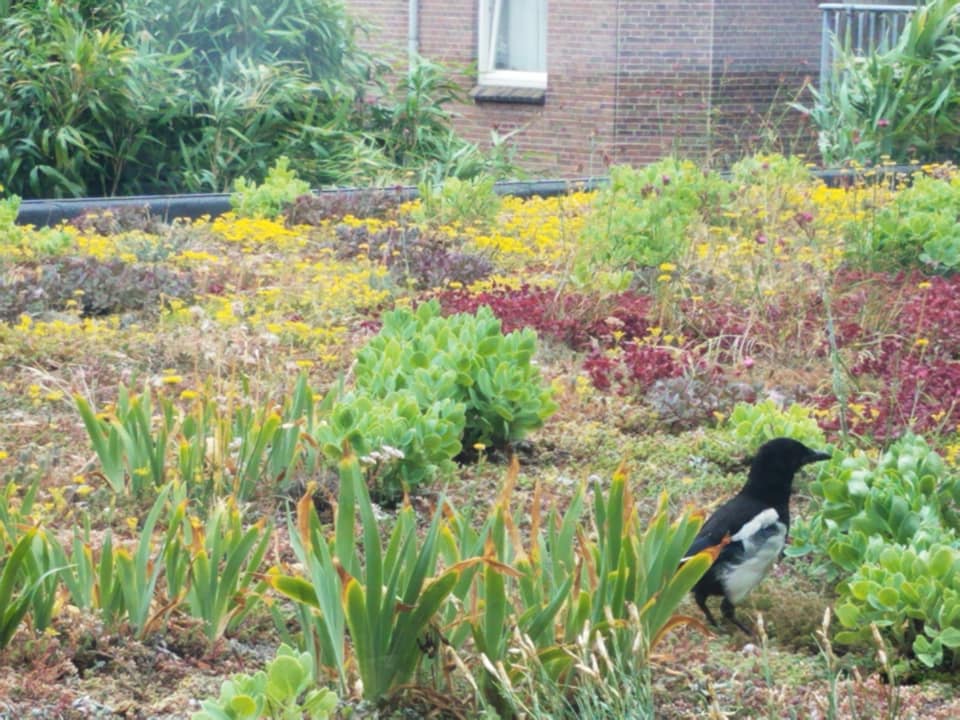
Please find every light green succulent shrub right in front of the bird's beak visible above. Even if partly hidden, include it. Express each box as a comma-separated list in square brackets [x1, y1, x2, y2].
[791, 434, 960, 667]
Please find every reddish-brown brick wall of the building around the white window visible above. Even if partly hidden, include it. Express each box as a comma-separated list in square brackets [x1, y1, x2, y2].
[346, 0, 820, 177]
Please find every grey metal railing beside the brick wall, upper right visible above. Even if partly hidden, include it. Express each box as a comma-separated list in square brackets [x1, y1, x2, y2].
[819, 3, 918, 92]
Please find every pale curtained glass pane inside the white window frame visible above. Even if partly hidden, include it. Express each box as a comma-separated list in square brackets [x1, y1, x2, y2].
[493, 0, 546, 72]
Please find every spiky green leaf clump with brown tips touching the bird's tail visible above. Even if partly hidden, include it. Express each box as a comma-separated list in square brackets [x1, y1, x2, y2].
[444, 462, 719, 715]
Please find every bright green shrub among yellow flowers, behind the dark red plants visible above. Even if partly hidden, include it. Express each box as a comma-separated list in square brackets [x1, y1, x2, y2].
[583, 159, 729, 268]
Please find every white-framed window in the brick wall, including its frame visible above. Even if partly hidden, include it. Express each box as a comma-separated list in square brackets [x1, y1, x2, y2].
[478, 0, 547, 88]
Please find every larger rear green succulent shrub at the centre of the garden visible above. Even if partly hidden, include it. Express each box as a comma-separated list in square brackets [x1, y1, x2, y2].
[355, 300, 556, 448]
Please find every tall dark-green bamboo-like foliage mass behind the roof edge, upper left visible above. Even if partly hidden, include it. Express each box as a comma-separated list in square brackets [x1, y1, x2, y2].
[0, 0, 512, 198]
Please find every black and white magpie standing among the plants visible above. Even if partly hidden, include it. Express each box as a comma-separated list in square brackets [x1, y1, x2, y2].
[687, 438, 830, 635]
